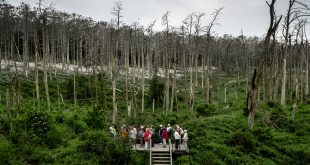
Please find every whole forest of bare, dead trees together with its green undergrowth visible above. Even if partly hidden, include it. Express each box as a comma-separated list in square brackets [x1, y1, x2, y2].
[0, 0, 310, 164]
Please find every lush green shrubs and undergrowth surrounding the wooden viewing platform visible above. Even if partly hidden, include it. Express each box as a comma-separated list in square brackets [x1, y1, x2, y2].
[0, 71, 310, 165]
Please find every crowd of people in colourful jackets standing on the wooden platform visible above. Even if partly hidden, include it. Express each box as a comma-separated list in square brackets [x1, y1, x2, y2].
[110, 124, 189, 149]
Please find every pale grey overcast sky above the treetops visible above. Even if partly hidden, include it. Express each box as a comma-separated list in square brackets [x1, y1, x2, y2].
[7, 0, 306, 36]
